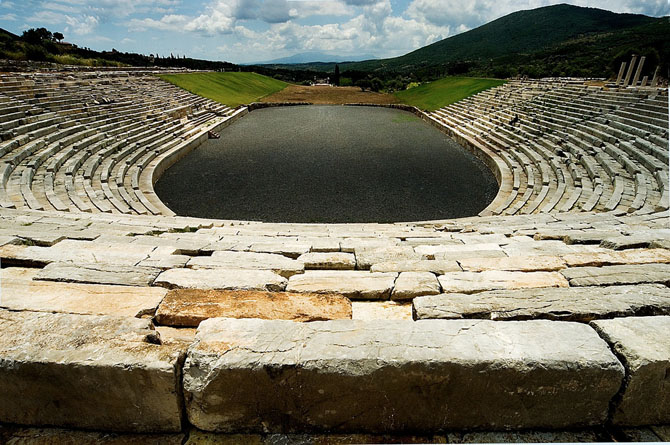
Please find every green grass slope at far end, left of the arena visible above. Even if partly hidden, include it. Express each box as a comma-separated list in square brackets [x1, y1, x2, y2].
[159, 73, 288, 107]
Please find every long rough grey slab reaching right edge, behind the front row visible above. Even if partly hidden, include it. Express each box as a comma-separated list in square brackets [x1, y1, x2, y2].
[413, 284, 670, 322]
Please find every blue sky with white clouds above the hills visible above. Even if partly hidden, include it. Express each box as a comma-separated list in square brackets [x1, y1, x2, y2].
[0, 0, 670, 63]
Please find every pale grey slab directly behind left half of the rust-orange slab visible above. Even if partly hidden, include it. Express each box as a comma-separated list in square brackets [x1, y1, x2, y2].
[154, 269, 288, 291]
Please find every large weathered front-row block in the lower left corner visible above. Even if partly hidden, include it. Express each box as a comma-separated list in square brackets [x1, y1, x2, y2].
[0, 310, 182, 432]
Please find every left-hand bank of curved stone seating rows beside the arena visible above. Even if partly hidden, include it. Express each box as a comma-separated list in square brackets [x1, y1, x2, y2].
[0, 74, 239, 214]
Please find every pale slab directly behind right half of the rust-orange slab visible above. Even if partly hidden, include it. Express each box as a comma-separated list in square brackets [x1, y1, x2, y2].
[286, 270, 398, 300]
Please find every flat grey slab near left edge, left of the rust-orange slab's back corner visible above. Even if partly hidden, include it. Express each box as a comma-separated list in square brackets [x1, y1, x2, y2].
[35, 263, 161, 286]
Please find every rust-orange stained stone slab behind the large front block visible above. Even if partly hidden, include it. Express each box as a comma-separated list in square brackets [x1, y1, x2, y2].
[156, 289, 351, 327]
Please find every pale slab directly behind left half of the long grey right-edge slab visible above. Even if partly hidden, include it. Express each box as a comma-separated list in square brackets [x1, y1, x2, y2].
[438, 270, 568, 294]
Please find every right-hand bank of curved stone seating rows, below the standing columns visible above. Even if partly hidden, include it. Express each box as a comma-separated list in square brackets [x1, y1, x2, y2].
[430, 81, 669, 215]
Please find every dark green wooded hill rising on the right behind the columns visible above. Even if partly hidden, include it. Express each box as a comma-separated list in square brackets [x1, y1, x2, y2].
[276, 4, 670, 80]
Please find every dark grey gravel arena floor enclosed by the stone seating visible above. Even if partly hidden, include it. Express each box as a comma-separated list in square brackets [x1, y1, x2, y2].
[156, 106, 498, 223]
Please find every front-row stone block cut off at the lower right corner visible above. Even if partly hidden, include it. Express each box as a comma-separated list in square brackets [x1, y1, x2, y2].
[591, 316, 670, 426]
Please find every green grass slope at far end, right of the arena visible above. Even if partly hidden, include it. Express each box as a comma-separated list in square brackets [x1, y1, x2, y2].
[395, 77, 505, 111]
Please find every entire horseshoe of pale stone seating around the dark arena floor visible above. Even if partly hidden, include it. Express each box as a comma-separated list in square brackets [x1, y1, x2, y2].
[0, 71, 670, 443]
